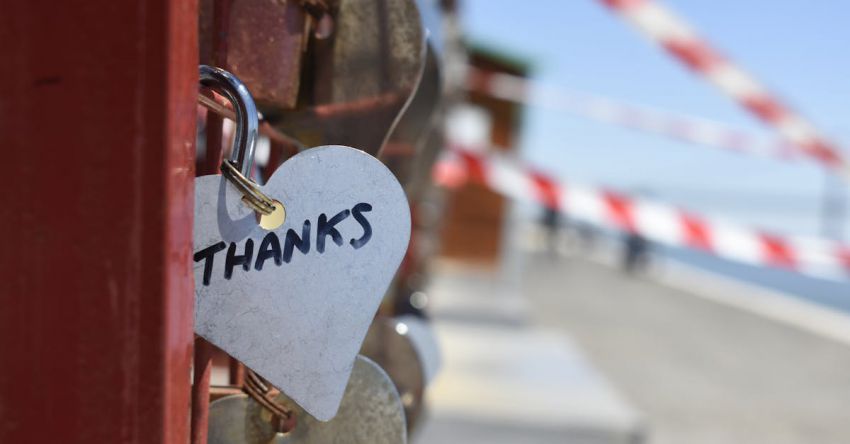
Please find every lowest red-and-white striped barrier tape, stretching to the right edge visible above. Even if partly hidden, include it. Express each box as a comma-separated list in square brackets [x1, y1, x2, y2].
[434, 147, 850, 278]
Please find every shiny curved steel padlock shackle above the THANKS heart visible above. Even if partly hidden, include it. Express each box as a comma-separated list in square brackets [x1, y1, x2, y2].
[200, 65, 260, 177]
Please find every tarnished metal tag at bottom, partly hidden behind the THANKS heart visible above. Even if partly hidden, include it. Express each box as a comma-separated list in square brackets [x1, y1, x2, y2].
[209, 356, 407, 444]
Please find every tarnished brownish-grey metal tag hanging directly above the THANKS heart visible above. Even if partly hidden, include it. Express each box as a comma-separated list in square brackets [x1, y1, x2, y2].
[274, 0, 426, 155]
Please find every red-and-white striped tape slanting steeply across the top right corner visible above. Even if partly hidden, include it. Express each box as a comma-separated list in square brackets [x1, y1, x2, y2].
[600, 0, 850, 177]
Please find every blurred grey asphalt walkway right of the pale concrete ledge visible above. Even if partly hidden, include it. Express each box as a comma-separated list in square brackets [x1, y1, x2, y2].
[522, 253, 850, 444]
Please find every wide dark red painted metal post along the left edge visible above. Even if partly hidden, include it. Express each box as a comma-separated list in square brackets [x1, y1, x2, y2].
[0, 0, 198, 444]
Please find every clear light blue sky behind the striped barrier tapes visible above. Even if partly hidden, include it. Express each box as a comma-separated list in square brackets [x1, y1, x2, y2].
[461, 0, 850, 239]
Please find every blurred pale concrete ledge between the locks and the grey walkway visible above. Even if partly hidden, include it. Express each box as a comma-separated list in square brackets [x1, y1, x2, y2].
[413, 265, 640, 444]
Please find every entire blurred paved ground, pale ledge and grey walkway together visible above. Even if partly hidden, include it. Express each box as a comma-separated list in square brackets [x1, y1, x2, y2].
[413, 213, 850, 444]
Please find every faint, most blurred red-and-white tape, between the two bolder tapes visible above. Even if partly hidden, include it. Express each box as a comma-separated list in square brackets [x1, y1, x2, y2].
[467, 67, 801, 164]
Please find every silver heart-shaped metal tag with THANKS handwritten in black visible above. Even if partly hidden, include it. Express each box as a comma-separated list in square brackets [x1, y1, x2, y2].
[194, 146, 410, 421]
